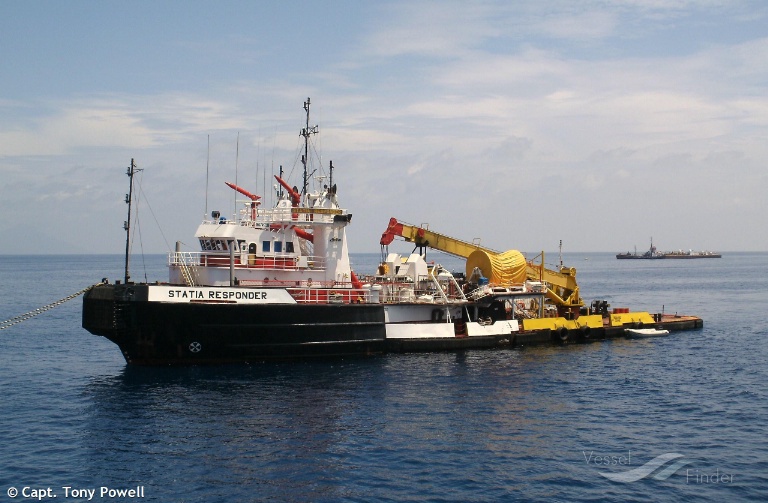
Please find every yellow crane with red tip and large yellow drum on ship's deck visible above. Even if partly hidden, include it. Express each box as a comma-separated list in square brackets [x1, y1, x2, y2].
[380, 218, 584, 316]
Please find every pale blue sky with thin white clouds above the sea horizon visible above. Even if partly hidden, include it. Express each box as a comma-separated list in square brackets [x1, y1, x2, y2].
[0, 0, 768, 253]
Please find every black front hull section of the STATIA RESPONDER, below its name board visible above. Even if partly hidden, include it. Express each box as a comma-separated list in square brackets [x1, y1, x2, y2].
[83, 285, 386, 365]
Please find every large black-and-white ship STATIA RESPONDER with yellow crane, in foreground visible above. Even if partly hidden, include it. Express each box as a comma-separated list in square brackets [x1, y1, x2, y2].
[82, 98, 703, 365]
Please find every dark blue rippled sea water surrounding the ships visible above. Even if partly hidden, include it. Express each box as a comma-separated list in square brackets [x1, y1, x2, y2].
[0, 253, 768, 503]
